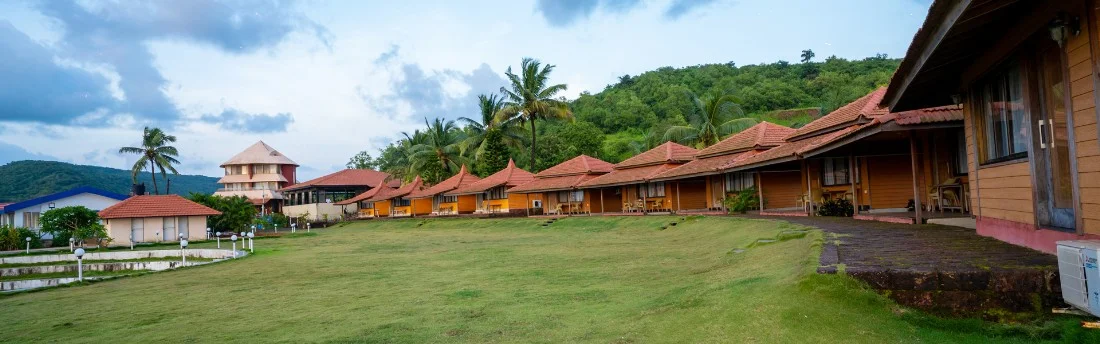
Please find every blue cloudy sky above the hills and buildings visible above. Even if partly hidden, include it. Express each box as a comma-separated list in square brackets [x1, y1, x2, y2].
[0, 0, 930, 180]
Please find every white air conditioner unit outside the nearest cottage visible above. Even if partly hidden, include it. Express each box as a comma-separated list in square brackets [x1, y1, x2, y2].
[1057, 240, 1100, 317]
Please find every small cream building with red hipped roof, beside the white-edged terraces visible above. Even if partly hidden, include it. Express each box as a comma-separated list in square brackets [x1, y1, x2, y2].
[99, 195, 221, 244]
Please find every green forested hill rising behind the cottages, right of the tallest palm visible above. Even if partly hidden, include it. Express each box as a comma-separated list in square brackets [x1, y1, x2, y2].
[550, 55, 900, 165]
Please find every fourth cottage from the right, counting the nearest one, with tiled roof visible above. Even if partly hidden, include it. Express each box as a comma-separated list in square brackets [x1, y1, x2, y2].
[580, 142, 697, 213]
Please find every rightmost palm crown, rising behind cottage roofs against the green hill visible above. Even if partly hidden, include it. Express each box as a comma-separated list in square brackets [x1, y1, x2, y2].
[664, 92, 756, 148]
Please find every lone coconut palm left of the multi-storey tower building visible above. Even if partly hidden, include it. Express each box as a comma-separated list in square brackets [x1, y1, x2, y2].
[119, 126, 179, 195]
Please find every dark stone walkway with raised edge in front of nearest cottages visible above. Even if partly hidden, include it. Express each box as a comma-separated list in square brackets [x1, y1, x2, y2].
[751, 215, 1062, 315]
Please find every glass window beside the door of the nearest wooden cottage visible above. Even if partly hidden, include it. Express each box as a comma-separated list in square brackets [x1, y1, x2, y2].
[976, 64, 1031, 164]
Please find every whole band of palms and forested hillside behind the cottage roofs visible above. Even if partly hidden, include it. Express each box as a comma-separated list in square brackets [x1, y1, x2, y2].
[347, 49, 900, 182]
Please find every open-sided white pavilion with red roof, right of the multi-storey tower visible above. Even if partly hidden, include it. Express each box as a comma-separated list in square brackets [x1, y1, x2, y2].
[279, 168, 396, 220]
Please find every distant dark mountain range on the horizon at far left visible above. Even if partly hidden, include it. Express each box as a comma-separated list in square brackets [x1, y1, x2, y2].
[0, 160, 218, 202]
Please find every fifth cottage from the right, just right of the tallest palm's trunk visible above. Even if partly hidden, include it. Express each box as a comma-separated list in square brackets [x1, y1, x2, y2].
[507, 155, 614, 214]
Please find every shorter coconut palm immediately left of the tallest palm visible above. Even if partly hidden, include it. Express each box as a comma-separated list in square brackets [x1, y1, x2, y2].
[459, 95, 523, 160]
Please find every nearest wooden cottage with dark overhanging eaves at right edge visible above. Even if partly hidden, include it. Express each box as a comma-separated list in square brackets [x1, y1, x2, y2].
[881, 0, 1100, 253]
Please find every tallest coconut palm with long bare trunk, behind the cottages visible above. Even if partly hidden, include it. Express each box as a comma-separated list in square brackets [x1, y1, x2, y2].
[497, 57, 573, 171]
